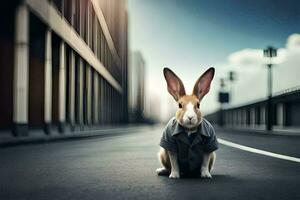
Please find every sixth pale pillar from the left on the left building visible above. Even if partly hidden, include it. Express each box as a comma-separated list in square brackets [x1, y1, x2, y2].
[86, 65, 92, 125]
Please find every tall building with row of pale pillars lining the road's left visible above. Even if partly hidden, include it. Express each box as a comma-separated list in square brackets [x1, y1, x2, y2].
[0, 0, 128, 135]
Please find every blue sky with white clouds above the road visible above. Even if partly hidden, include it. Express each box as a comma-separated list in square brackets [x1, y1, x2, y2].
[128, 0, 300, 118]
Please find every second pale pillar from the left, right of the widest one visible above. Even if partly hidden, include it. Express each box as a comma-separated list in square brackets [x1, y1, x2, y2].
[44, 29, 52, 134]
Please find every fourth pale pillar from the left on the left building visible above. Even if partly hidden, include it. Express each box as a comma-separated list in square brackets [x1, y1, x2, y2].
[68, 50, 75, 130]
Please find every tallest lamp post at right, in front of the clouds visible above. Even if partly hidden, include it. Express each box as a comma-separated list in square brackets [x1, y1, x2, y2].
[264, 46, 277, 131]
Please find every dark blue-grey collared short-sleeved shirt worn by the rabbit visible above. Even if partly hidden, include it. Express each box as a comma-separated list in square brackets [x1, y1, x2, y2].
[160, 117, 219, 172]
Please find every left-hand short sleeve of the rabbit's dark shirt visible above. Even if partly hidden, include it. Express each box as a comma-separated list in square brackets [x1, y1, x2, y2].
[159, 120, 177, 152]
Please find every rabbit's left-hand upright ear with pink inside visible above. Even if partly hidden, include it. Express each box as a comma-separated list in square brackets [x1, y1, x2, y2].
[164, 68, 185, 101]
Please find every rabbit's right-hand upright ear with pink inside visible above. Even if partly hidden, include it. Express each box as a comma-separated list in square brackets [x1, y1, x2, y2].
[193, 67, 215, 100]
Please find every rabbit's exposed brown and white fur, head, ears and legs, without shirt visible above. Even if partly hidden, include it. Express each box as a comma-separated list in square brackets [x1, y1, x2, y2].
[156, 68, 216, 178]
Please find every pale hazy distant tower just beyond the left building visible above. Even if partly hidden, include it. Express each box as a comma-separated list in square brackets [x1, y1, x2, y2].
[129, 51, 145, 122]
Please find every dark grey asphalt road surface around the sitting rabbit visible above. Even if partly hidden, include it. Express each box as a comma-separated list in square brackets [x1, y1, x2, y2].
[0, 127, 300, 200]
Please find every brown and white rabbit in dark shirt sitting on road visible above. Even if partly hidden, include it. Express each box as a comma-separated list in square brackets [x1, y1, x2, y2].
[156, 68, 218, 179]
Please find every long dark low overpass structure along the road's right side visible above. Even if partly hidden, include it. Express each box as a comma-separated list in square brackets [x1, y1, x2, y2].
[205, 87, 300, 133]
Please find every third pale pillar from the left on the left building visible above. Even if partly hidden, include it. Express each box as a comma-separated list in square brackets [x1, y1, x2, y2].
[58, 41, 66, 133]
